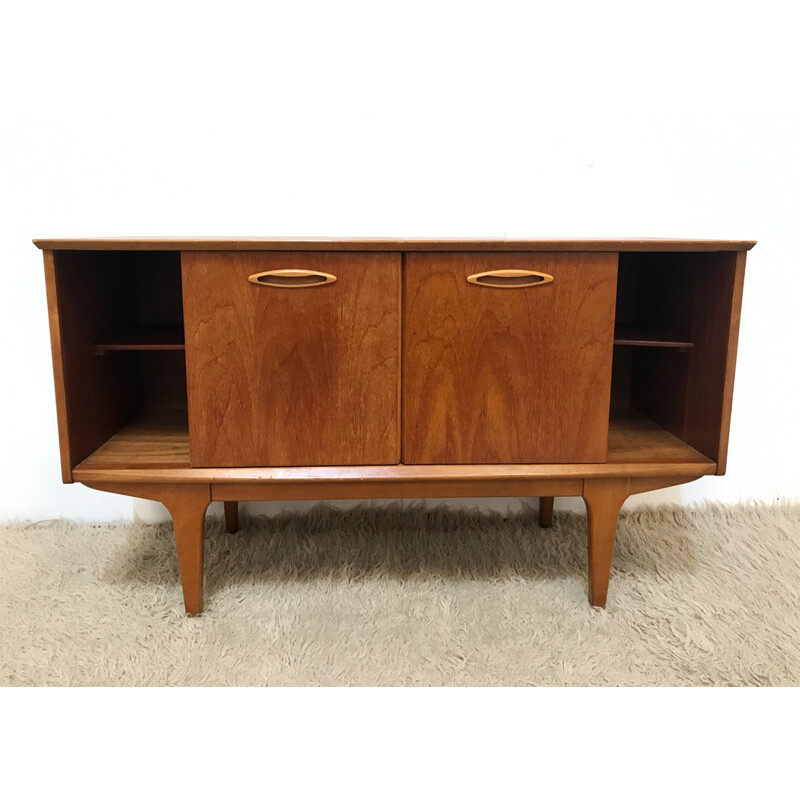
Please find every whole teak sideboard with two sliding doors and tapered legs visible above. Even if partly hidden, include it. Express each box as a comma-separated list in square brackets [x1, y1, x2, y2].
[35, 239, 755, 615]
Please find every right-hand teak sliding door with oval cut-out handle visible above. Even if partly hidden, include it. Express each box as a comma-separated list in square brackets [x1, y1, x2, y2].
[403, 253, 617, 464]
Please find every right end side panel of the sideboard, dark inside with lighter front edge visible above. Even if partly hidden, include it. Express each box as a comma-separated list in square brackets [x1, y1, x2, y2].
[683, 252, 746, 475]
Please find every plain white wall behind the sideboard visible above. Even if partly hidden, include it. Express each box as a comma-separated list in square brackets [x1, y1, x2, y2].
[0, 0, 800, 520]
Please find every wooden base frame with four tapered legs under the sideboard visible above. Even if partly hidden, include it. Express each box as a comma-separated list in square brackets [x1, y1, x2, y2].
[84, 475, 700, 617]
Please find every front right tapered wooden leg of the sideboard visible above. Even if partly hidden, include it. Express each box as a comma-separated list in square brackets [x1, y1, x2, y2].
[583, 478, 630, 608]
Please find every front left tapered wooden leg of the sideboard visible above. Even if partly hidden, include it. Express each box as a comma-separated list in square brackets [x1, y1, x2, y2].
[162, 484, 211, 617]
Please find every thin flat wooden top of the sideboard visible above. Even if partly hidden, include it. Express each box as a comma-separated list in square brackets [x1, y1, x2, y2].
[33, 237, 755, 252]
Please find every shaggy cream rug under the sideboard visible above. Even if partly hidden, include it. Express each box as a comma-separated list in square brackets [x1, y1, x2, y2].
[0, 505, 800, 686]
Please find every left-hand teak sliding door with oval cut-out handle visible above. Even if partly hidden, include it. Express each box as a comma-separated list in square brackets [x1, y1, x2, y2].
[181, 252, 401, 467]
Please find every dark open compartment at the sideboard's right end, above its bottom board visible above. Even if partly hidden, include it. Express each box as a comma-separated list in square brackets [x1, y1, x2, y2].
[611, 252, 736, 461]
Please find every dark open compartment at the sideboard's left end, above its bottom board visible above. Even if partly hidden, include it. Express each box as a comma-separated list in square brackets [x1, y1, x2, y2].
[54, 250, 186, 476]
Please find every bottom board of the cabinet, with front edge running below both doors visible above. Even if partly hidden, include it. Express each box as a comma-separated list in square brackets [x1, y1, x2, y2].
[73, 408, 716, 483]
